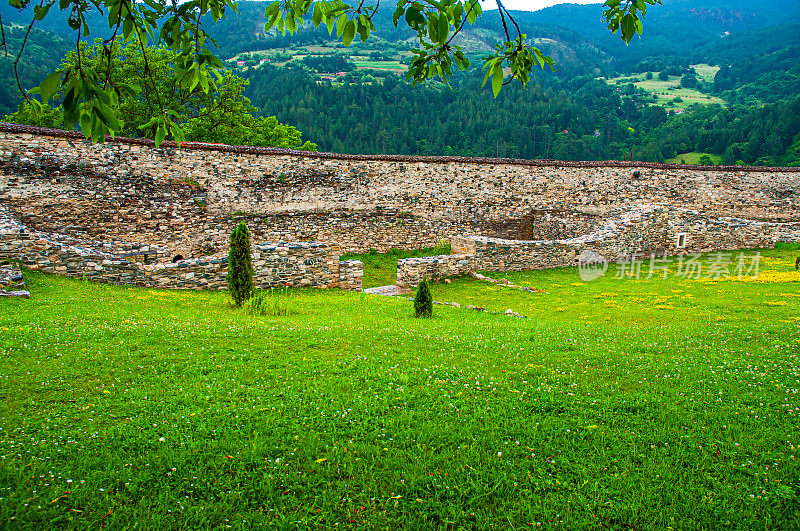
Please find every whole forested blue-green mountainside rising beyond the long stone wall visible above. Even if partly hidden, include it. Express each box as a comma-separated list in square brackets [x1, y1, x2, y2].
[0, 0, 800, 165]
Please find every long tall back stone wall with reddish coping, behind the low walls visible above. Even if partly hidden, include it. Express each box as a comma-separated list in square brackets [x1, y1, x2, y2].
[0, 124, 800, 258]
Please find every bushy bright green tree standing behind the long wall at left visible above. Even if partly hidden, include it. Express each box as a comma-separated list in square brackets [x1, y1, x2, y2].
[7, 38, 317, 151]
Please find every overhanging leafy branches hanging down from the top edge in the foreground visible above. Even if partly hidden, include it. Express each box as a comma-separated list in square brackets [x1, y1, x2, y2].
[0, 0, 661, 143]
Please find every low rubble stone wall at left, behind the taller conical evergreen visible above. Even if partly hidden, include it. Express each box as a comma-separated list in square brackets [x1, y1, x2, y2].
[0, 204, 363, 290]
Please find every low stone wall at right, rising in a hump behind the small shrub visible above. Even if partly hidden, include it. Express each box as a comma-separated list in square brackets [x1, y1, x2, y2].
[397, 205, 800, 287]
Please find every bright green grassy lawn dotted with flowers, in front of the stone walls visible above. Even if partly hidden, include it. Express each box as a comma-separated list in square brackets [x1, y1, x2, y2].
[0, 250, 800, 530]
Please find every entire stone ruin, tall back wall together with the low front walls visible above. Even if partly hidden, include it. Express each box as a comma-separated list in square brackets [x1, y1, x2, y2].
[0, 123, 800, 289]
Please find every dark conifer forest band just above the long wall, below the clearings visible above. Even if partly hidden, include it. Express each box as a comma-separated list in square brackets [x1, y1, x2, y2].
[247, 67, 800, 165]
